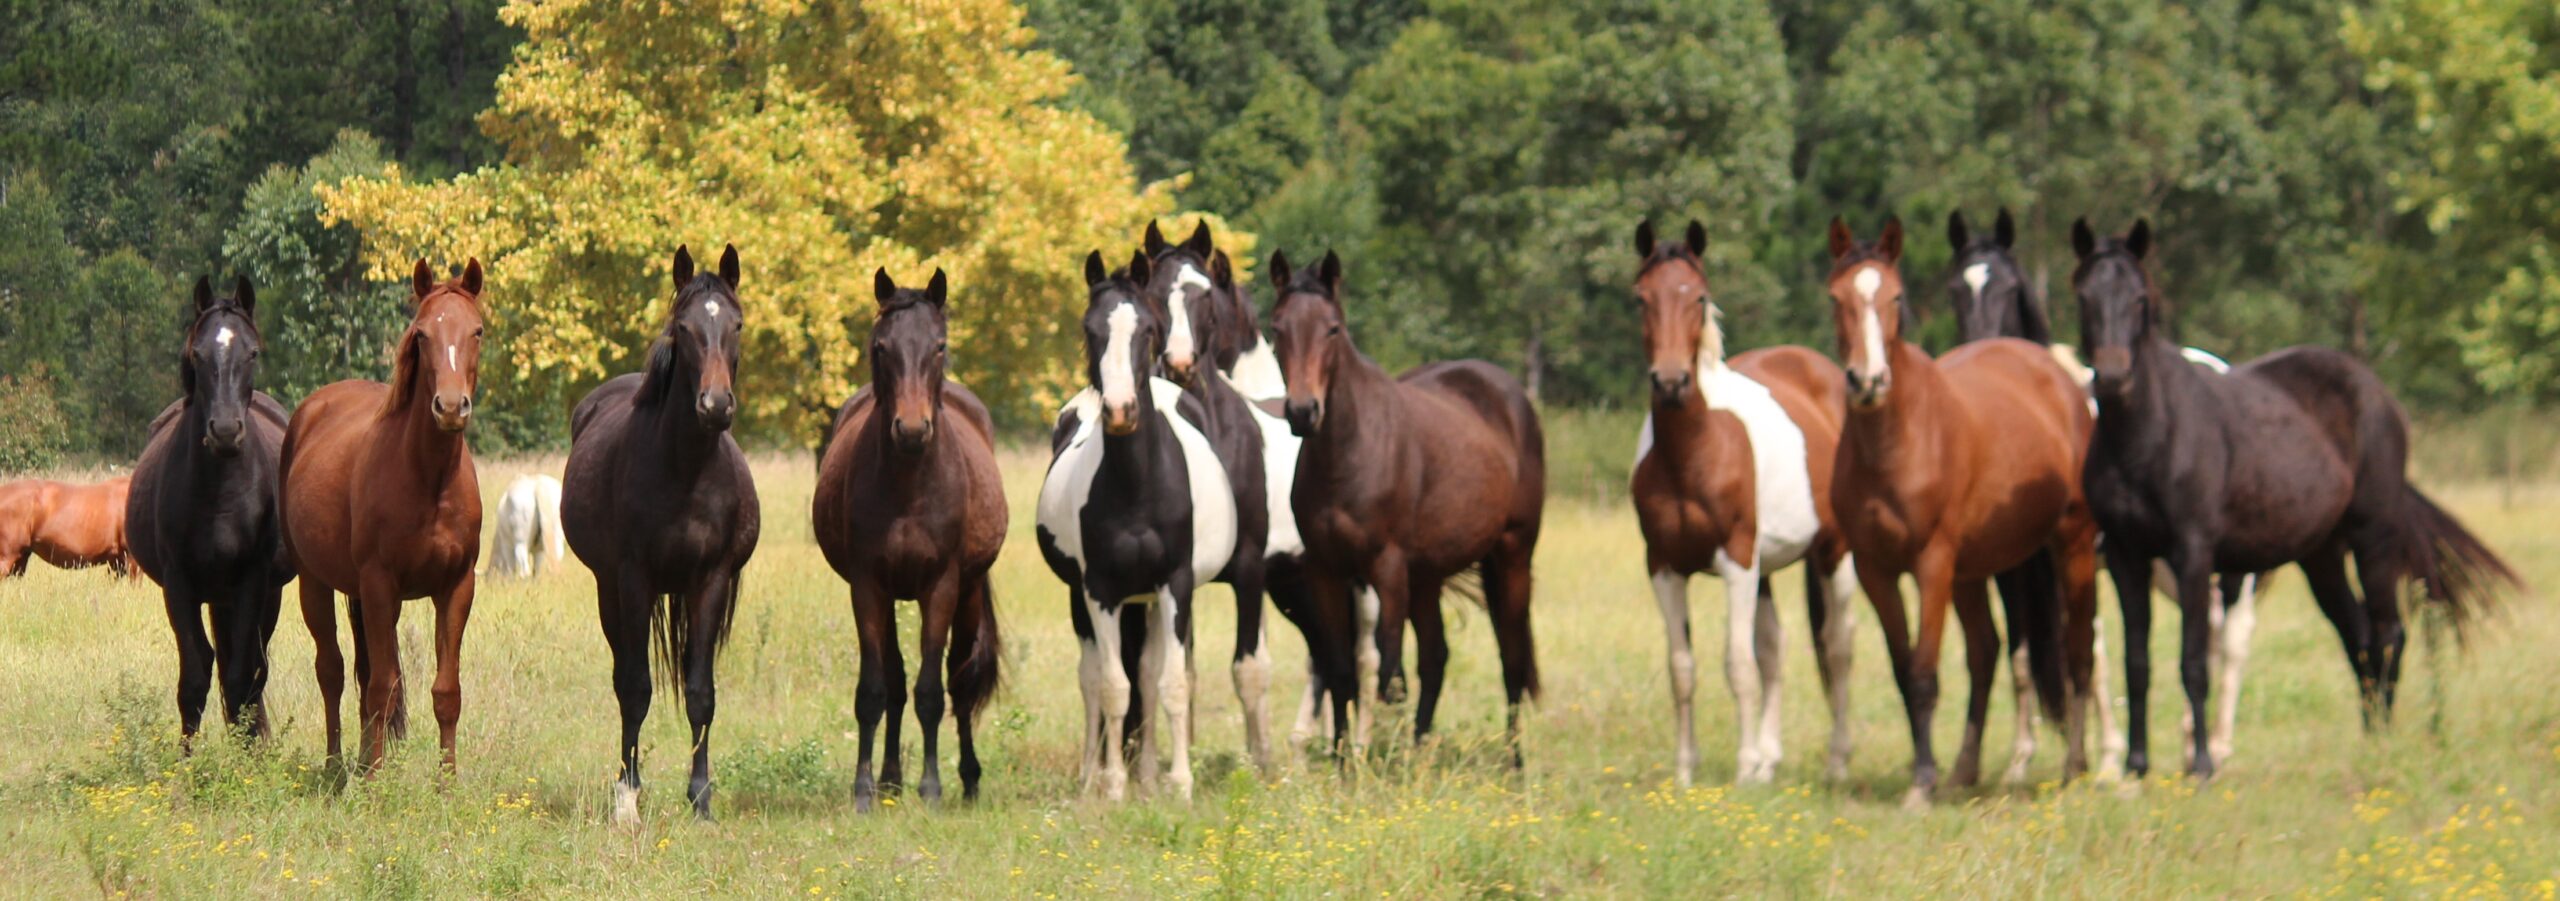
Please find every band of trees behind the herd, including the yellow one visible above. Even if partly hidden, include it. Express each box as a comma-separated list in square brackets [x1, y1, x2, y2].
[0, 0, 2560, 468]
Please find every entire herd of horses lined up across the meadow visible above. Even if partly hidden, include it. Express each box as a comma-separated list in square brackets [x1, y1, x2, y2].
[0, 210, 2516, 822]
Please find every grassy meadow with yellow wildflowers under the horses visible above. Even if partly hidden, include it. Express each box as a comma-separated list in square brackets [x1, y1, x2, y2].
[0, 432, 2560, 898]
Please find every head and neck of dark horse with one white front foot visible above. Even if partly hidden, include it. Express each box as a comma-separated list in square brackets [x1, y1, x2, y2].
[640, 243, 745, 433]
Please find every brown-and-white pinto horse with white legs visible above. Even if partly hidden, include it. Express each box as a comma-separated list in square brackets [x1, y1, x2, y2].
[1628, 220, 1856, 786]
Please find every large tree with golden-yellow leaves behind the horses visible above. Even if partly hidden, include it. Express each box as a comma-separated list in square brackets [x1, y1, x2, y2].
[320, 0, 1224, 443]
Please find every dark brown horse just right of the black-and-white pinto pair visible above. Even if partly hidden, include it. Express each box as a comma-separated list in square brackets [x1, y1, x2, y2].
[1270, 251, 1546, 768]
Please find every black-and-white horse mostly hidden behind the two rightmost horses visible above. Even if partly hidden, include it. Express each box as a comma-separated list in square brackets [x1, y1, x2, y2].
[1946, 207, 2258, 783]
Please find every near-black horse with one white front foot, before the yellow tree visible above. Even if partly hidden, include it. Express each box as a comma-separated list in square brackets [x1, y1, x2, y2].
[561, 246, 763, 827]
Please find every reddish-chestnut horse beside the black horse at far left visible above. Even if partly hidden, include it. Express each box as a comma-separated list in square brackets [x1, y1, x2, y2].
[279, 259, 481, 773]
